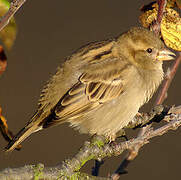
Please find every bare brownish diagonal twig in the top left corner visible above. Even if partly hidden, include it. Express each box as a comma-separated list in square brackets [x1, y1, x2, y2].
[0, 0, 26, 31]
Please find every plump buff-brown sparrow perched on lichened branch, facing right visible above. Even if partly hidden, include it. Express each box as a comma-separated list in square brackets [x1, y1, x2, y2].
[5, 27, 175, 152]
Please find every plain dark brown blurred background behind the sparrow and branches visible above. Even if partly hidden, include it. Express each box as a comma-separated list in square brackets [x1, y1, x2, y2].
[0, 0, 181, 180]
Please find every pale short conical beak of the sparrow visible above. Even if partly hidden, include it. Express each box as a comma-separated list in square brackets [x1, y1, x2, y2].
[156, 49, 176, 61]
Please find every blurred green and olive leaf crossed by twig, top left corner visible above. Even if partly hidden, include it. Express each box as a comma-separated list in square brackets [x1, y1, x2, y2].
[0, 0, 17, 49]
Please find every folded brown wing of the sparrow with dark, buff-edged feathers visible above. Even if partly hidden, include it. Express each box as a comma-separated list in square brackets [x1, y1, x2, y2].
[43, 58, 129, 128]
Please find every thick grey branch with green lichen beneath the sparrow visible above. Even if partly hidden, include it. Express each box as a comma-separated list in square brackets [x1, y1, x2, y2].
[0, 106, 181, 180]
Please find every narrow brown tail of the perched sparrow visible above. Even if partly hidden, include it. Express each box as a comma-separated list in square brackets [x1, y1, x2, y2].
[5, 115, 42, 152]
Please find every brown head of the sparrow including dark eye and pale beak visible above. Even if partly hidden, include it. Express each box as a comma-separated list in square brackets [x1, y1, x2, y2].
[118, 27, 175, 69]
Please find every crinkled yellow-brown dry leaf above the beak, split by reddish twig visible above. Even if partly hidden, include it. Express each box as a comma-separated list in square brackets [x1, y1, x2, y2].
[140, 2, 181, 51]
